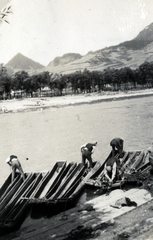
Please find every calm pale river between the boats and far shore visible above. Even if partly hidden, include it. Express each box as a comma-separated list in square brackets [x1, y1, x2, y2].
[0, 96, 153, 185]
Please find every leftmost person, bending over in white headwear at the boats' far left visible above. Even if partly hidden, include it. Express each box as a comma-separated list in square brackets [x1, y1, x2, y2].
[5, 155, 25, 182]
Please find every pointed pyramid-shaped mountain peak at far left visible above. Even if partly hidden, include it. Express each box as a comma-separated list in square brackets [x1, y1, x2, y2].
[5, 53, 44, 74]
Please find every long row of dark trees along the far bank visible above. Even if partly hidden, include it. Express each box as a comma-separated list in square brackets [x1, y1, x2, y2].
[0, 62, 153, 99]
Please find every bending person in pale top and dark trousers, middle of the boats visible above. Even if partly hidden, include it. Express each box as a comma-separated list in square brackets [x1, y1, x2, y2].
[81, 141, 97, 168]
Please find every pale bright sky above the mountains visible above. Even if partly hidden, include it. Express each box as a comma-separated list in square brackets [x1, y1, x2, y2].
[0, 0, 153, 66]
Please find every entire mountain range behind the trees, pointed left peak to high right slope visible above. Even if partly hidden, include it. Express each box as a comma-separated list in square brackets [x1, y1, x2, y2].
[6, 23, 153, 74]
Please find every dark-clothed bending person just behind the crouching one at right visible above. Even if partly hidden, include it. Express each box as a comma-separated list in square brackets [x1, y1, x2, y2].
[110, 138, 124, 158]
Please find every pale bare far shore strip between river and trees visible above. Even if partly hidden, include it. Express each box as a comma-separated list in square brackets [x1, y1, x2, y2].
[0, 89, 153, 113]
